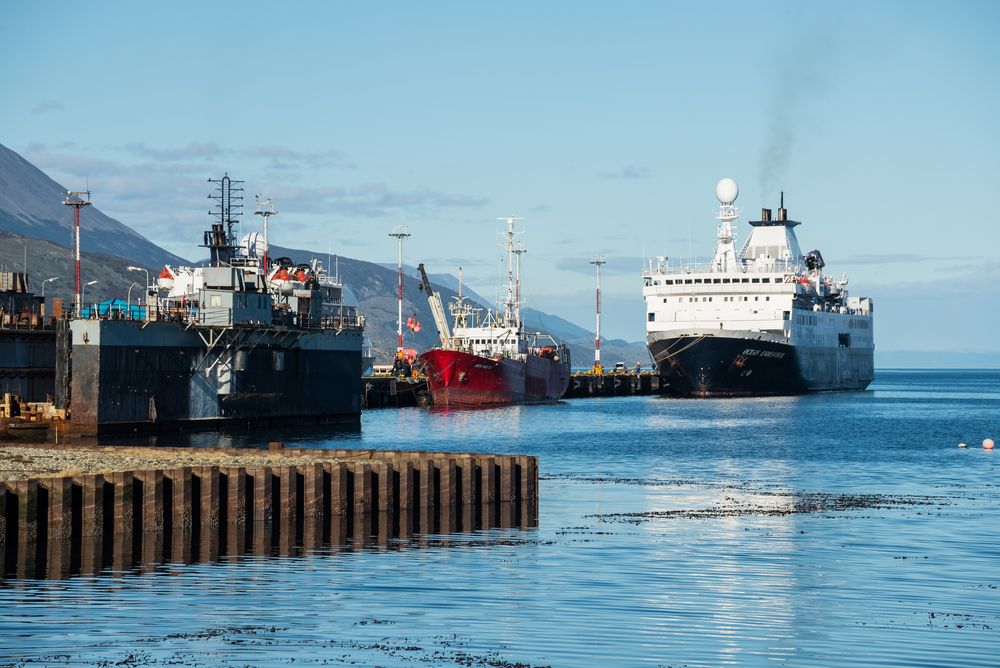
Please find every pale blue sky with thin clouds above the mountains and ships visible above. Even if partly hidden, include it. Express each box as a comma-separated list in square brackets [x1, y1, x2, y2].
[0, 1, 1000, 351]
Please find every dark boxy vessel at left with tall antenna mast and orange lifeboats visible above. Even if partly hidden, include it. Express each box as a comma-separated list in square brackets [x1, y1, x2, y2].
[64, 177, 364, 433]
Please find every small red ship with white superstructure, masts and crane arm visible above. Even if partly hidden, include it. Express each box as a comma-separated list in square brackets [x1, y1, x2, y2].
[419, 218, 570, 406]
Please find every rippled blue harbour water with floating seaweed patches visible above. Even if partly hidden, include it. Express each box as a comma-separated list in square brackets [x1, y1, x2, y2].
[0, 371, 1000, 666]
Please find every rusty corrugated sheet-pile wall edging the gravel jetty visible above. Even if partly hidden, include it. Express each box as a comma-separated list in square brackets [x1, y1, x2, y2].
[0, 456, 538, 579]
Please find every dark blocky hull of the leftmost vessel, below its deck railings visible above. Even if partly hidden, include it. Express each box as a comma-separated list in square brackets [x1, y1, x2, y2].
[70, 320, 361, 433]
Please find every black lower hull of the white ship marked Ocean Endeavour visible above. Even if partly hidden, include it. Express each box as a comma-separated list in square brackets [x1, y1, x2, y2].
[649, 332, 874, 397]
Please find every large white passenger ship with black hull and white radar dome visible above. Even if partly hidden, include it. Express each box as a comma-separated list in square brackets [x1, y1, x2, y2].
[642, 178, 875, 397]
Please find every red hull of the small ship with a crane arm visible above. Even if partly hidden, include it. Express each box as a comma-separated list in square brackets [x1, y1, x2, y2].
[420, 348, 570, 406]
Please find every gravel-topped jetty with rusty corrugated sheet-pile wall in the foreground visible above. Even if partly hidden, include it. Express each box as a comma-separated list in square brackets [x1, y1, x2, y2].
[0, 445, 538, 578]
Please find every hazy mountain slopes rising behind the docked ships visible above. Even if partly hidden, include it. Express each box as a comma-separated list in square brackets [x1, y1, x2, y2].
[0, 145, 648, 367]
